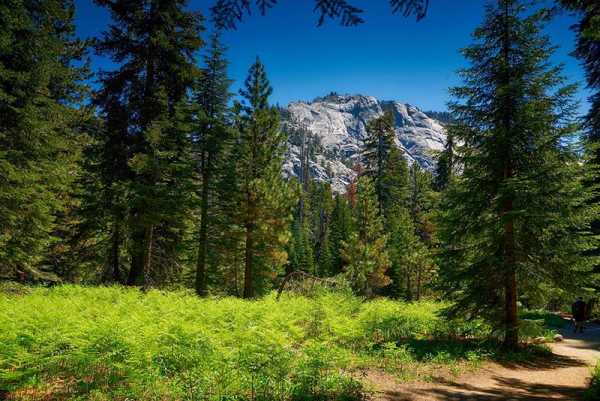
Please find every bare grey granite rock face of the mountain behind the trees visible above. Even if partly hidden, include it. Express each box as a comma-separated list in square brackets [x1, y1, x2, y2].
[283, 94, 446, 192]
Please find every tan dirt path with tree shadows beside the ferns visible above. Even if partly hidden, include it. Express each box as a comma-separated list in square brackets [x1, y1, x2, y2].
[373, 325, 600, 401]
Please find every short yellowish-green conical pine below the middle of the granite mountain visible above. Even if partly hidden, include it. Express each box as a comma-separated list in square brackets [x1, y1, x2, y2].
[342, 176, 390, 296]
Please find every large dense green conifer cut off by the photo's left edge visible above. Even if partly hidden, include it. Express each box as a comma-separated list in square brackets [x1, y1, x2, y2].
[0, 0, 88, 280]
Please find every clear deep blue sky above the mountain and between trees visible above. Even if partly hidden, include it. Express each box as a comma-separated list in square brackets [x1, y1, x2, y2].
[75, 0, 587, 111]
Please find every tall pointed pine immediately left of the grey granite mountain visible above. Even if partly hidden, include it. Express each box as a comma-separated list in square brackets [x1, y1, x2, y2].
[234, 58, 293, 298]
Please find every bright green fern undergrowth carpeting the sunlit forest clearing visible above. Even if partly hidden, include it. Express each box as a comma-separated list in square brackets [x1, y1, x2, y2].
[0, 285, 556, 401]
